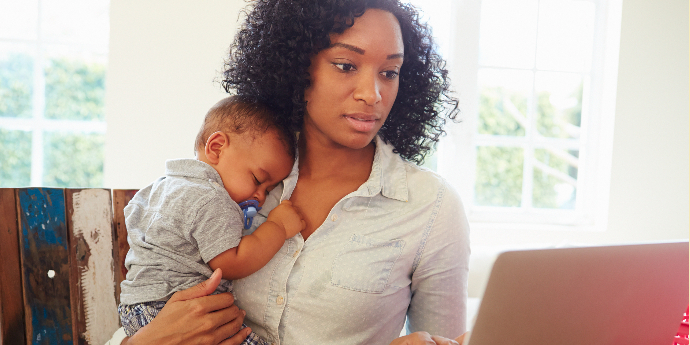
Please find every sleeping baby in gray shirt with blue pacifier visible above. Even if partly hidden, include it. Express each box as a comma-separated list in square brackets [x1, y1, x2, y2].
[118, 96, 305, 344]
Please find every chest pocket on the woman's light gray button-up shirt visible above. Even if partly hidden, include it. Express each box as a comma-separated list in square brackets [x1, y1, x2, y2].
[331, 234, 405, 293]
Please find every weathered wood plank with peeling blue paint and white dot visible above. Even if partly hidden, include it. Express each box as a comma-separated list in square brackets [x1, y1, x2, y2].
[17, 188, 73, 345]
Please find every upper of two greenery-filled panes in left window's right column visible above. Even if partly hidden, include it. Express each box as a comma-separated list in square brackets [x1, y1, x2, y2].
[45, 50, 105, 121]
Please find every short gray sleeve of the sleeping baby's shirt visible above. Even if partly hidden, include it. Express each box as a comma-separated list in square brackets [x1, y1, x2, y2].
[190, 192, 244, 263]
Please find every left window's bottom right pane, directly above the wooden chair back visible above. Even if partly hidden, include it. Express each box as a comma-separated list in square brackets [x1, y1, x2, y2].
[43, 132, 105, 188]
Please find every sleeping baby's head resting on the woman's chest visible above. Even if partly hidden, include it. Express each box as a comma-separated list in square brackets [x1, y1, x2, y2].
[194, 96, 295, 205]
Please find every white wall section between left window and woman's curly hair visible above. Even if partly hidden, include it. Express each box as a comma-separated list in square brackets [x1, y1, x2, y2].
[104, 0, 245, 188]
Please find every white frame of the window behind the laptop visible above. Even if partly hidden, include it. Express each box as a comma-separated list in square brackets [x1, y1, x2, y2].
[436, 0, 622, 231]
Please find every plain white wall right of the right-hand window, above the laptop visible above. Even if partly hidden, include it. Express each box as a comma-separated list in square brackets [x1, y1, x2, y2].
[608, 0, 690, 241]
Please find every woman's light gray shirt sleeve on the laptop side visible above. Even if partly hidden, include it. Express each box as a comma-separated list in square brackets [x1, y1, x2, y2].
[407, 184, 470, 339]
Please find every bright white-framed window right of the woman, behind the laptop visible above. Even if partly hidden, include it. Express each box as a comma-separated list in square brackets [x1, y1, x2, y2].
[406, 0, 621, 229]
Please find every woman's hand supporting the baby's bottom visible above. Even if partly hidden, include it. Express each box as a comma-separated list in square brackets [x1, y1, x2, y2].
[122, 269, 251, 345]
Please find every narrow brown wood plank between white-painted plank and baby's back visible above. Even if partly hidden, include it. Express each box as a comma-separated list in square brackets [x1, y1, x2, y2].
[113, 189, 138, 303]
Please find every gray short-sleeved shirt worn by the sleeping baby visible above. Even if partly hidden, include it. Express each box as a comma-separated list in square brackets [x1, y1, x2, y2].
[120, 159, 243, 304]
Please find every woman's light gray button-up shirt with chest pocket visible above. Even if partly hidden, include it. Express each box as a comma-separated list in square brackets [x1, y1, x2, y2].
[234, 137, 470, 345]
